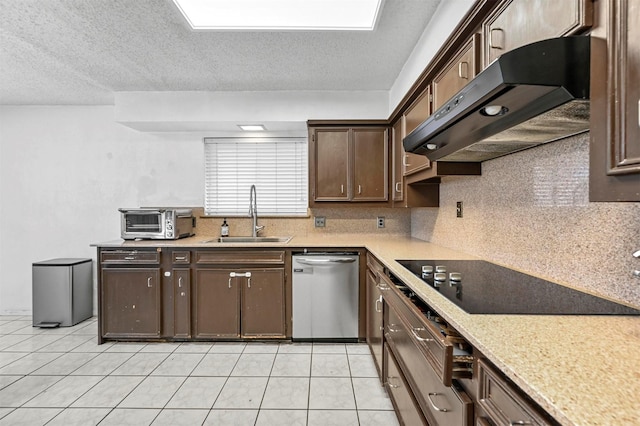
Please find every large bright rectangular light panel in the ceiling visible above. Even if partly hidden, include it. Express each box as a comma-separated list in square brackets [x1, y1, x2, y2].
[173, 0, 384, 31]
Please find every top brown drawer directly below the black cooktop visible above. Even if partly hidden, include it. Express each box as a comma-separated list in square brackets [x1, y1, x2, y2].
[383, 284, 471, 386]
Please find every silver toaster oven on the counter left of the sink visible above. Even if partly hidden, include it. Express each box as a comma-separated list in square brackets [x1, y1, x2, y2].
[118, 207, 195, 240]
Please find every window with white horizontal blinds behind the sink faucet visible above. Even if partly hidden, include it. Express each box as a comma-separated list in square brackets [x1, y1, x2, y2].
[204, 138, 308, 216]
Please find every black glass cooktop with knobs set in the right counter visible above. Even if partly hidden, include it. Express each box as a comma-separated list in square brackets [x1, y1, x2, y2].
[397, 260, 640, 315]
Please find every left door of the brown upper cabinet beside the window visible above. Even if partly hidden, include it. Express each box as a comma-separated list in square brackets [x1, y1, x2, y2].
[312, 129, 349, 201]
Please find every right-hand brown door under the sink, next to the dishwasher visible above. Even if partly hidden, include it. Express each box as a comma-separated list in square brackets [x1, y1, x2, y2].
[240, 268, 286, 338]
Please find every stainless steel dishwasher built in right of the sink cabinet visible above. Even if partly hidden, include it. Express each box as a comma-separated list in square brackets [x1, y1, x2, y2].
[292, 252, 359, 341]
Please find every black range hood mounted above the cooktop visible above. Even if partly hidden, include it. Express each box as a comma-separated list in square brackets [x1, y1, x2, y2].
[403, 36, 591, 162]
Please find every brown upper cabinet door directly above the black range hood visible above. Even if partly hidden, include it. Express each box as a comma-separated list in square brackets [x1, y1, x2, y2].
[483, 0, 593, 65]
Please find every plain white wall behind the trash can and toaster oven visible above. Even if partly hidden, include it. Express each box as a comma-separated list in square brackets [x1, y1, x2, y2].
[0, 106, 204, 314]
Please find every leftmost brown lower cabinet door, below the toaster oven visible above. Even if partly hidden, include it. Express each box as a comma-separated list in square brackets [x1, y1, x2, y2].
[101, 268, 161, 337]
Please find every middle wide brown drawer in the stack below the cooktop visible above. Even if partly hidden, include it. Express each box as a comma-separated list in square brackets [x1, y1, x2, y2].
[385, 307, 473, 426]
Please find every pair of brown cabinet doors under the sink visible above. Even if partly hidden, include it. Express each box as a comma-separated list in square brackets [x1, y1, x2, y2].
[192, 267, 286, 338]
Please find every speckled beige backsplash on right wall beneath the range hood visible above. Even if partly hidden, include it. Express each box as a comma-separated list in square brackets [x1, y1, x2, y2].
[411, 134, 640, 307]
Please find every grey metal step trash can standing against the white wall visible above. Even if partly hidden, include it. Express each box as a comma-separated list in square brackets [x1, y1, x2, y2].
[32, 258, 93, 327]
